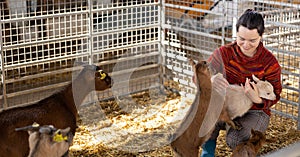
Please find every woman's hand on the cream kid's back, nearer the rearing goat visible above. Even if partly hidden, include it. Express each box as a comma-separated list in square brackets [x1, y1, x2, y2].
[211, 73, 229, 96]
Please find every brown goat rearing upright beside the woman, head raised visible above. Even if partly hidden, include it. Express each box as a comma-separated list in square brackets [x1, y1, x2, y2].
[171, 60, 214, 157]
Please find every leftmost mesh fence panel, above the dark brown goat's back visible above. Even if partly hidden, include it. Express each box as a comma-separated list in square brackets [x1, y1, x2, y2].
[1, 0, 89, 106]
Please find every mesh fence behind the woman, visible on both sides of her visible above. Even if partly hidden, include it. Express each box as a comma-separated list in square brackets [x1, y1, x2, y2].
[162, 0, 300, 128]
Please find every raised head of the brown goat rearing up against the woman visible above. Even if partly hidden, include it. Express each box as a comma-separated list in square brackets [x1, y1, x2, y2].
[189, 59, 211, 85]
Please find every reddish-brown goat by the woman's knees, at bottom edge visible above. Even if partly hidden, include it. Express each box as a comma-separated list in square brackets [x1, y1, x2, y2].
[232, 129, 269, 157]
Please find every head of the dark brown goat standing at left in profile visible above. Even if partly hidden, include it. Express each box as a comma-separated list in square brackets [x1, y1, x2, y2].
[79, 65, 113, 91]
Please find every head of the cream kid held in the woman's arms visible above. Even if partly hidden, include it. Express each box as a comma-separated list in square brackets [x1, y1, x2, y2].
[252, 75, 276, 100]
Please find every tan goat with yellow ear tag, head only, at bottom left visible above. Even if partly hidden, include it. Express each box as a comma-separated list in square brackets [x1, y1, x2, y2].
[16, 123, 73, 157]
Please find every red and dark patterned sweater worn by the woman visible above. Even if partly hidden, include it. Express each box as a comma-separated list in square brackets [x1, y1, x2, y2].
[208, 42, 282, 115]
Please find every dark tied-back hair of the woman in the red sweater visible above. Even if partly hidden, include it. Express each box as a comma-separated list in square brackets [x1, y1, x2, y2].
[236, 9, 265, 36]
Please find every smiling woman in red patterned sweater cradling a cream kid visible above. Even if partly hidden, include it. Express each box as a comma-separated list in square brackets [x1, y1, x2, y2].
[201, 9, 282, 157]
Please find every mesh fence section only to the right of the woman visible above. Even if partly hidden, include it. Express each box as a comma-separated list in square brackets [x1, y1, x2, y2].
[257, 1, 300, 129]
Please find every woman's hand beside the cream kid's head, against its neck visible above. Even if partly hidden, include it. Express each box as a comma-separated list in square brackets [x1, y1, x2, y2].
[241, 78, 263, 104]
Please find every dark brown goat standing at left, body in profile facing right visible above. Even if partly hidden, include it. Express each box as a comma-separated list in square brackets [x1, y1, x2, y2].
[0, 65, 112, 157]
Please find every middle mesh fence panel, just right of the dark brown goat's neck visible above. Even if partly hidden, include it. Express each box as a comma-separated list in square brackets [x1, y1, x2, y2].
[90, 1, 160, 100]
